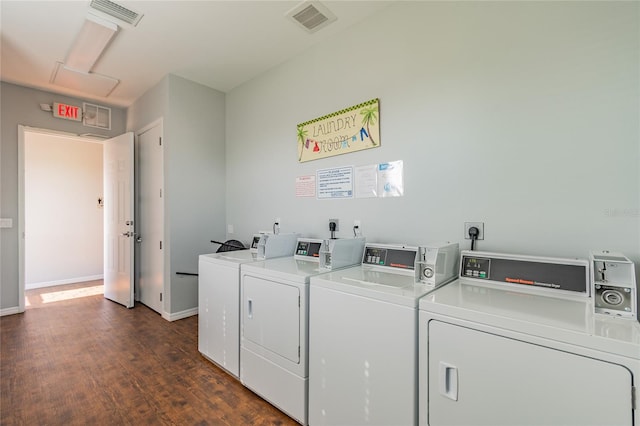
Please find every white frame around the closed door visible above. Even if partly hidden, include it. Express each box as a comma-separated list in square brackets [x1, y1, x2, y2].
[134, 117, 172, 321]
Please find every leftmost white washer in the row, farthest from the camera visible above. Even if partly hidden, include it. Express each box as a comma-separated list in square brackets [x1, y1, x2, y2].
[198, 234, 298, 378]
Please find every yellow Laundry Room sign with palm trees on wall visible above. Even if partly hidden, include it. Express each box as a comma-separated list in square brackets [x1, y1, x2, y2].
[298, 98, 380, 163]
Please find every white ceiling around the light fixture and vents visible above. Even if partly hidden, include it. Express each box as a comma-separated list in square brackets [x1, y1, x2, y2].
[0, 0, 392, 107]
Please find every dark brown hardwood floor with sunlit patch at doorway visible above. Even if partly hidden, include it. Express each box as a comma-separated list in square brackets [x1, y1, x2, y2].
[0, 281, 297, 426]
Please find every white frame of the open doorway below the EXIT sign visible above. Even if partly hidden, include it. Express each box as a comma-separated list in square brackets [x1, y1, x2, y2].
[18, 124, 104, 313]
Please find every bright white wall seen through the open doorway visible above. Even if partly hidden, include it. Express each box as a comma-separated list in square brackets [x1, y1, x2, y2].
[25, 132, 104, 289]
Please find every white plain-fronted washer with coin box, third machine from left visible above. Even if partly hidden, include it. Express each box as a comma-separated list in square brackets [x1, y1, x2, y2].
[309, 244, 459, 425]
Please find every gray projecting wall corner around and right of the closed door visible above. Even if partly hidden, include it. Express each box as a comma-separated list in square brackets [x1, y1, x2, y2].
[127, 75, 225, 314]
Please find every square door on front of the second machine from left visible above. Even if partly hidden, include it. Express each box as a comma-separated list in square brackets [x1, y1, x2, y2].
[242, 275, 300, 364]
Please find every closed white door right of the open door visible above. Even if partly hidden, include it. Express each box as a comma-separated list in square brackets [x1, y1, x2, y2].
[136, 124, 164, 314]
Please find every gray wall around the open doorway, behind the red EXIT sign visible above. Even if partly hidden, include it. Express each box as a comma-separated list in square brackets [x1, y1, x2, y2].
[0, 82, 125, 309]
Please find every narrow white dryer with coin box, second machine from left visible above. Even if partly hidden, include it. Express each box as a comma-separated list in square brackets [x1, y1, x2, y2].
[240, 238, 364, 424]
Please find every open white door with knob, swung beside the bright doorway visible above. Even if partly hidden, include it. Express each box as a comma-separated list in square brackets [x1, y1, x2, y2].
[103, 132, 135, 308]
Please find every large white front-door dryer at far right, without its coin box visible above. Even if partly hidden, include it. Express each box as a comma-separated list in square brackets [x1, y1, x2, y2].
[419, 251, 640, 426]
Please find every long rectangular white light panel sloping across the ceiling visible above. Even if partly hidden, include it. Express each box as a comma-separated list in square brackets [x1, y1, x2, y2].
[65, 13, 118, 73]
